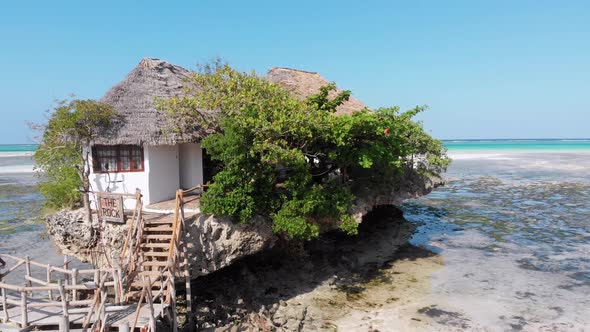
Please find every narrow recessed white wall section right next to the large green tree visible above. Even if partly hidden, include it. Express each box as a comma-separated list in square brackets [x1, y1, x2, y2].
[178, 143, 203, 189]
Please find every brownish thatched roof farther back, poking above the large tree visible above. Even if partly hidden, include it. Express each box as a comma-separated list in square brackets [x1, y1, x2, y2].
[266, 67, 366, 115]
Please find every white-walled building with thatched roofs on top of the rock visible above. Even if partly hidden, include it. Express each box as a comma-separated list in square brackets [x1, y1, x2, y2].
[89, 58, 365, 206]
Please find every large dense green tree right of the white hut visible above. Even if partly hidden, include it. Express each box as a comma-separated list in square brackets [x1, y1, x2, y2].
[159, 63, 448, 239]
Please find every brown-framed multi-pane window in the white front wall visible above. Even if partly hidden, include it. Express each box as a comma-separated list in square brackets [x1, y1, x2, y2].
[92, 145, 143, 173]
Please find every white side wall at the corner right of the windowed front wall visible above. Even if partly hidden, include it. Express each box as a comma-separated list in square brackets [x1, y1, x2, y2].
[146, 145, 180, 205]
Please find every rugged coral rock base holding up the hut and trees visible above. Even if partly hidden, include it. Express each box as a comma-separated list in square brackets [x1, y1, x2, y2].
[46, 174, 443, 278]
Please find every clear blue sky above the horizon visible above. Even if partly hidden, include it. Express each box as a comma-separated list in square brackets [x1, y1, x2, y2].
[0, 0, 590, 143]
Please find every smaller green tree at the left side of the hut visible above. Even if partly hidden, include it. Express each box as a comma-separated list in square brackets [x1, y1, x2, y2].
[33, 100, 115, 209]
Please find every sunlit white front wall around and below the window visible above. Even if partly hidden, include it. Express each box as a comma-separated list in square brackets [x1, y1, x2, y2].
[89, 147, 153, 209]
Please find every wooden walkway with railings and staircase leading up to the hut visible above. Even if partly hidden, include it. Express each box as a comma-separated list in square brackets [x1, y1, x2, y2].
[0, 186, 202, 332]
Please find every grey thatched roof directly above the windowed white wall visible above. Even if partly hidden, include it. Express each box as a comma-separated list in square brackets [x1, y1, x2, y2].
[93, 58, 198, 145]
